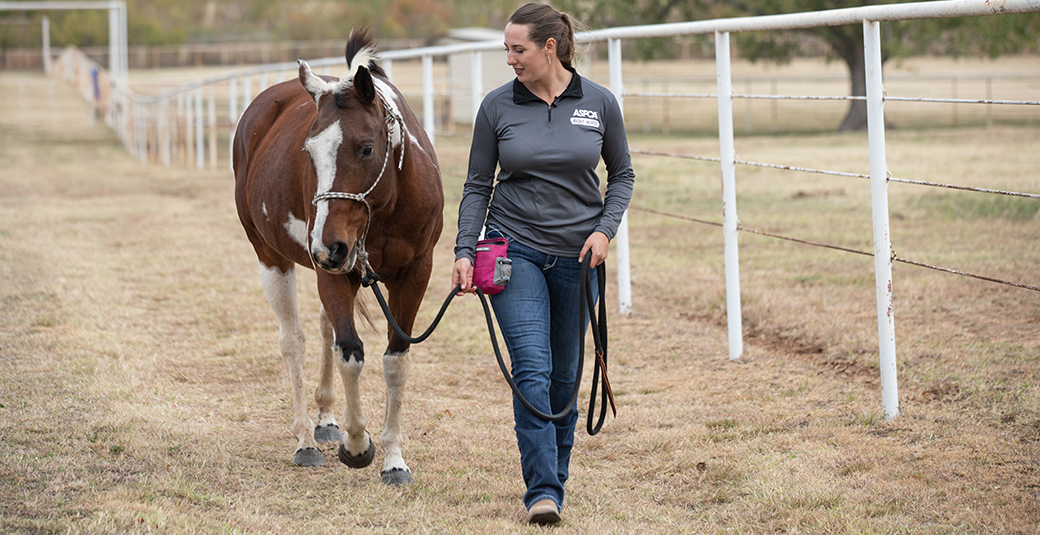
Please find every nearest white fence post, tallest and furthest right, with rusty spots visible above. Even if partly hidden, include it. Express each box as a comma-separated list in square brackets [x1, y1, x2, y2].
[863, 21, 900, 418]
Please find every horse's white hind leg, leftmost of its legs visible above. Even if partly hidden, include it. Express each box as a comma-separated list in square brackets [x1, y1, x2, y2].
[260, 262, 324, 466]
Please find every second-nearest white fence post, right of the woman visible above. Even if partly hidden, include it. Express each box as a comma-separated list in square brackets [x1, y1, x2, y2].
[716, 31, 744, 360]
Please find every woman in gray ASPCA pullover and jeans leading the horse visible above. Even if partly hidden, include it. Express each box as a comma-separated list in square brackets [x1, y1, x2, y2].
[451, 3, 634, 524]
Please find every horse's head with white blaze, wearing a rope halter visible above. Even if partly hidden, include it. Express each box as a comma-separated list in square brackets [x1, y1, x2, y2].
[300, 34, 404, 274]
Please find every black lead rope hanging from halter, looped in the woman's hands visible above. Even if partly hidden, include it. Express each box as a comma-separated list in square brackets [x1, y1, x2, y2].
[361, 251, 618, 435]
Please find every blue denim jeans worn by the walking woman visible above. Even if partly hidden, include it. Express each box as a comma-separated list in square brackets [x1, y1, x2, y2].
[486, 227, 599, 508]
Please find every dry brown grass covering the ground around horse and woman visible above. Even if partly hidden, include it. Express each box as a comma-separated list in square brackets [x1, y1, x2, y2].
[0, 60, 1040, 534]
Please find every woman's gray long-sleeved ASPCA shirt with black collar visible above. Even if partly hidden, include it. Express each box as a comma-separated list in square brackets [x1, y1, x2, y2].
[456, 70, 635, 259]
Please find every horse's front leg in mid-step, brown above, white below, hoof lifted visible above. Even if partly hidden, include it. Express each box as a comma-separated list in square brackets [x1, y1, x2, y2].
[318, 272, 375, 468]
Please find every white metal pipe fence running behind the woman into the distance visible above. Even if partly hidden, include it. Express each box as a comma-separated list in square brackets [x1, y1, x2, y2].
[48, 0, 1040, 418]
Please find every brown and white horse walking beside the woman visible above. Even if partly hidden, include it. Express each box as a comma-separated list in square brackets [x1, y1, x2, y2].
[234, 32, 444, 484]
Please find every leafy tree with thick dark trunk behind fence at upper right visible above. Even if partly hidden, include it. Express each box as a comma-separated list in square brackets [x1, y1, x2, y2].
[561, 0, 1040, 130]
